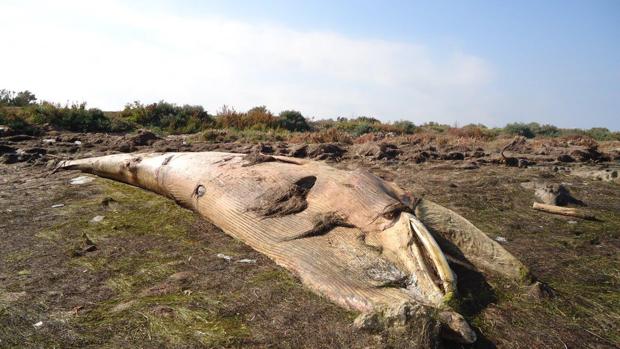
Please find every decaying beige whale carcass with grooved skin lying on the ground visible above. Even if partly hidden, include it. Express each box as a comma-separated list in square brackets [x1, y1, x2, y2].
[59, 152, 528, 343]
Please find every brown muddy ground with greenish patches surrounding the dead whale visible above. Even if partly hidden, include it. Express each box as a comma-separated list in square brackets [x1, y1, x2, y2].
[0, 133, 620, 348]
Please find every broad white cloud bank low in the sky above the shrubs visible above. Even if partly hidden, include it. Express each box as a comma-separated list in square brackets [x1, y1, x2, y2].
[0, 1, 492, 123]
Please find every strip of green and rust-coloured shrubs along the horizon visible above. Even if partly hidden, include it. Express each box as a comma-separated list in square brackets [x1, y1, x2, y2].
[0, 89, 620, 143]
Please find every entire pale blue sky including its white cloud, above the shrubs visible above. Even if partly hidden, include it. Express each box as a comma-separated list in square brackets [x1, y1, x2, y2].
[0, 0, 620, 130]
